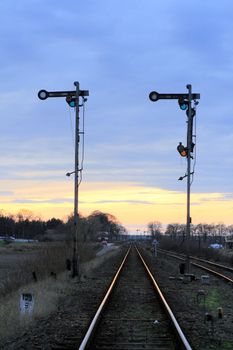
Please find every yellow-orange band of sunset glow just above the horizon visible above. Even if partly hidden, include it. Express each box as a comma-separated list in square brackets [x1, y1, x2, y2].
[2, 181, 233, 229]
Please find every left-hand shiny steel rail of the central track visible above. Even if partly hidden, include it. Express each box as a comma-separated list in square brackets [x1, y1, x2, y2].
[79, 246, 131, 350]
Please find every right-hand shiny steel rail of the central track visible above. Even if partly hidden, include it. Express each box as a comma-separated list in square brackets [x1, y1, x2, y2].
[135, 247, 192, 350]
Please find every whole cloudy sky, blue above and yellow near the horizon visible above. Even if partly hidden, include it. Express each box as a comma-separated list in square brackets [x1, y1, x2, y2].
[0, 0, 233, 232]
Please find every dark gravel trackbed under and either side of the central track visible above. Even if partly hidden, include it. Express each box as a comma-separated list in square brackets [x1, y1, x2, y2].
[4, 245, 233, 350]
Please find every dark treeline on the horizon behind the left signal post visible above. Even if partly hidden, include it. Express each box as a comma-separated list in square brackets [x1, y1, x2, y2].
[0, 210, 126, 242]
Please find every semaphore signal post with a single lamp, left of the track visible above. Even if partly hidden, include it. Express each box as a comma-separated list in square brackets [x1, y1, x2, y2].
[38, 81, 89, 277]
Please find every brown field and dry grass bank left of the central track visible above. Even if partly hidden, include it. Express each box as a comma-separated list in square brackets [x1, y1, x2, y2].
[0, 242, 102, 342]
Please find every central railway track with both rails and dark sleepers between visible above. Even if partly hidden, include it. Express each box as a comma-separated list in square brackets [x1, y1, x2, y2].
[79, 247, 191, 350]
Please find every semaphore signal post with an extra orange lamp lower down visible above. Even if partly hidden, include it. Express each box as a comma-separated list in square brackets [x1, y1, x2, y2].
[149, 84, 200, 272]
